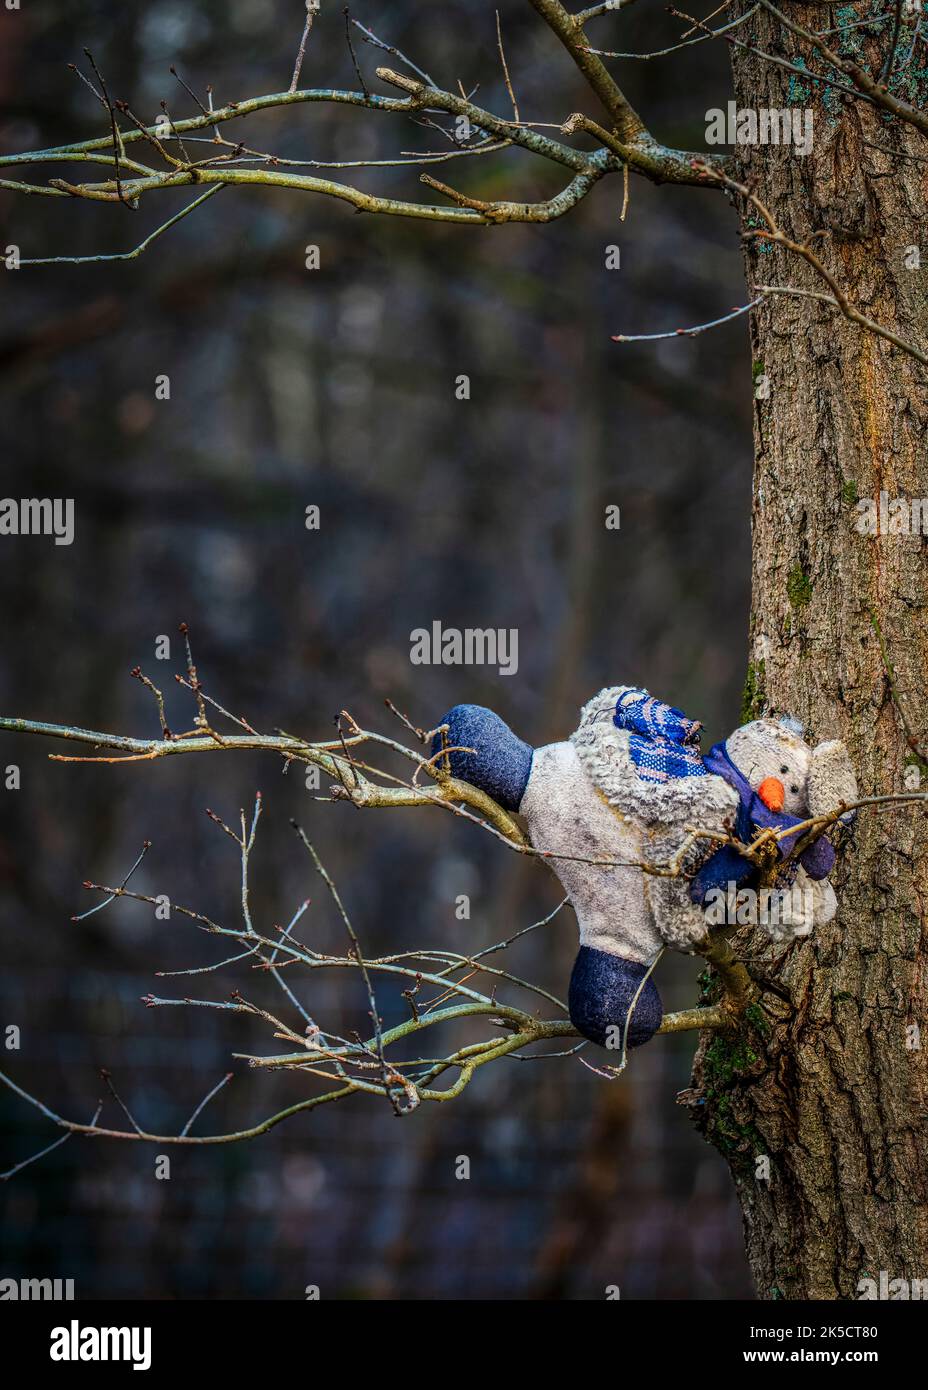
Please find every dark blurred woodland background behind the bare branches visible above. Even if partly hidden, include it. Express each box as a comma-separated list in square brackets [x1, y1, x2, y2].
[0, 0, 752, 1300]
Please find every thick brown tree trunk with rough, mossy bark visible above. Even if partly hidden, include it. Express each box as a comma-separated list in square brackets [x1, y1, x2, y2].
[692, 0, 928, 1298]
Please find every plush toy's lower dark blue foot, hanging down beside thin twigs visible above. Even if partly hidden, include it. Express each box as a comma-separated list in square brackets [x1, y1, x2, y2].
[567, 947, 664, 1052]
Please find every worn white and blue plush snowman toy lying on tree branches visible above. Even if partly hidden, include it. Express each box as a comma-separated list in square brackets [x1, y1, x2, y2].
[432, 685, 857, 1047]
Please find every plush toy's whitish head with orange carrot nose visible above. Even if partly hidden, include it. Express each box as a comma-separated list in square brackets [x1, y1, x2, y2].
[725, 719, 857, 817]
